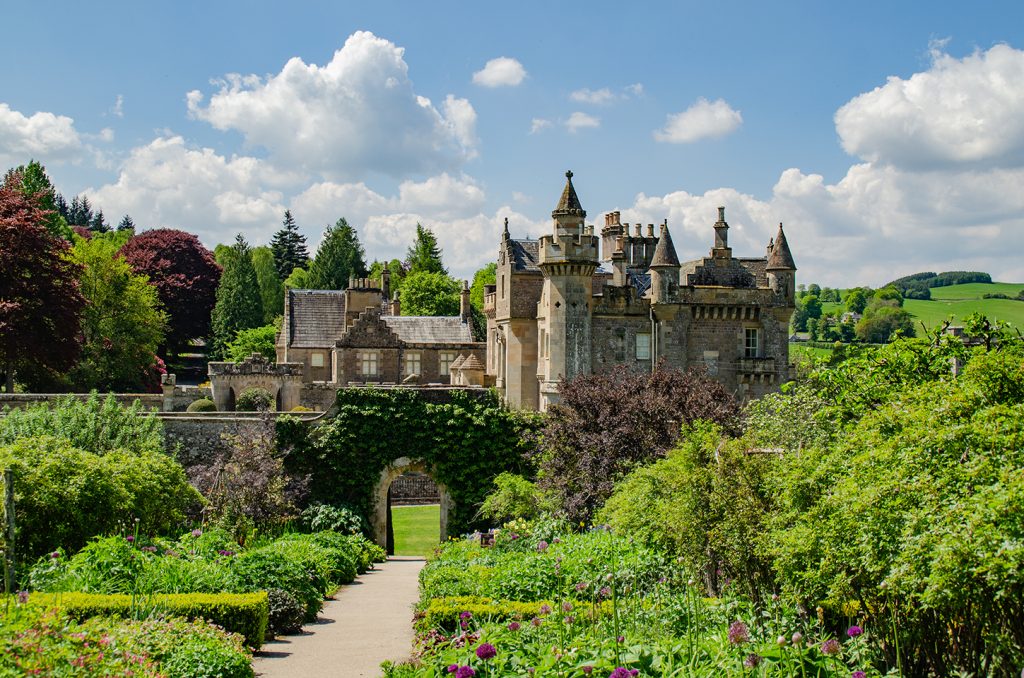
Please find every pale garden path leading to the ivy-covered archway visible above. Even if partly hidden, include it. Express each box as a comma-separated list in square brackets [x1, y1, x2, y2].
[253, 556, 424, 678]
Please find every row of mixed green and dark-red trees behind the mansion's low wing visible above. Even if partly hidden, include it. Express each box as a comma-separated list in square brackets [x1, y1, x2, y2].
[0, 161, 495, 392]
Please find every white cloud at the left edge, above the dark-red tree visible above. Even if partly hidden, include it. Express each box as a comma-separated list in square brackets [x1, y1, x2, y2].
[0, 103, 84, 167]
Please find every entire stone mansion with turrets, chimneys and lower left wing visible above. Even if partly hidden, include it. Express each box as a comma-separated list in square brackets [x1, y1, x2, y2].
[235, 172, 797, 411]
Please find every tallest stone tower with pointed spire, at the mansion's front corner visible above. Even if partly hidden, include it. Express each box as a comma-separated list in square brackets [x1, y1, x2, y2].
[537, 171, 599, 410]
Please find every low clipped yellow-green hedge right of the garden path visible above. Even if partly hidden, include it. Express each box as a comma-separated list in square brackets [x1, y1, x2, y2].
[416, 596, 611, 632]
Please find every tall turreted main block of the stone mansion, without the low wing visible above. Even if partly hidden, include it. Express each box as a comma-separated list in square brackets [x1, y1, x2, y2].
[484, 172, 797, 411]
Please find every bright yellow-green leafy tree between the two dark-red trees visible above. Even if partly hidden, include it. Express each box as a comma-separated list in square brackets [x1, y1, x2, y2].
[68, 234, 167, 392]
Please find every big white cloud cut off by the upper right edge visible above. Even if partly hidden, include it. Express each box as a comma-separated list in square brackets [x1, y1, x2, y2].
[836, 44, 1024, 168]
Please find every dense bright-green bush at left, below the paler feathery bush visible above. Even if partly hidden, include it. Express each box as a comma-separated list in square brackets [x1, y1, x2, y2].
[0, 436, 202, 557]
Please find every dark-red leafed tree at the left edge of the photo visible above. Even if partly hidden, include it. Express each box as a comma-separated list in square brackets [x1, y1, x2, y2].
[0, 183, 85, 392]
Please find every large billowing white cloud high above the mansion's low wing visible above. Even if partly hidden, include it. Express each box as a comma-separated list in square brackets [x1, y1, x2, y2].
[186, 32, 476, 178]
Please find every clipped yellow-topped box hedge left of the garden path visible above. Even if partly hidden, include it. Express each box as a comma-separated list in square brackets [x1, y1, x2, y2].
[29, 591, 269, 650]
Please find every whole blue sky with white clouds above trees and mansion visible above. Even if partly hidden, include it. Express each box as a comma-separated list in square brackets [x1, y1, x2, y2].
[0, 0, 1024, 287]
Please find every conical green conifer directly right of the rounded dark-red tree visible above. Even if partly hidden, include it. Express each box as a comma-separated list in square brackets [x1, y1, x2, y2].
[210, 234, 263, 358]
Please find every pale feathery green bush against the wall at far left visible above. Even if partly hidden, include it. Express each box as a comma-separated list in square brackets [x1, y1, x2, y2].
[0, 391, 164, 455]
